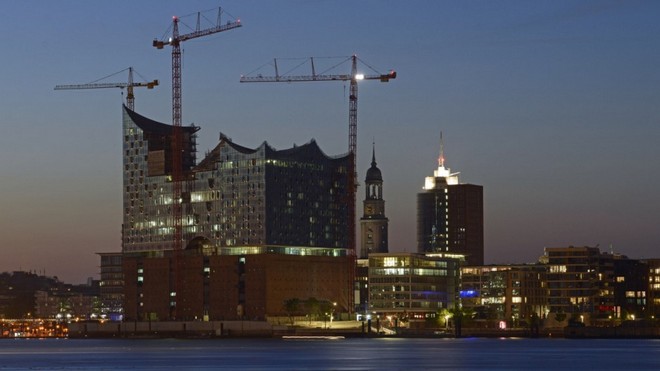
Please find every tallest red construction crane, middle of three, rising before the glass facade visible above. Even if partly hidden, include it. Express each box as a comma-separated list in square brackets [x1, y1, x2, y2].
[152, 8, 241, 318]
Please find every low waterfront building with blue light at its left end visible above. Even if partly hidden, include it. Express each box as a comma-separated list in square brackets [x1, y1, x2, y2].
[460, 264, 548, 327]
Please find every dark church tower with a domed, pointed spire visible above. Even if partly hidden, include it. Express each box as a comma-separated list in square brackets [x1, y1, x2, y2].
[359, 144, 389, 259]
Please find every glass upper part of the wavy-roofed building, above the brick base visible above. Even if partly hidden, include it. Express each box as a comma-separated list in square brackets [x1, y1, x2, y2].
[122, 108, 349, 256]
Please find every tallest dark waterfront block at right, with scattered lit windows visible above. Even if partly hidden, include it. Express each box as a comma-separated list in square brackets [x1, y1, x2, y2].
[545, 246, 620, 323]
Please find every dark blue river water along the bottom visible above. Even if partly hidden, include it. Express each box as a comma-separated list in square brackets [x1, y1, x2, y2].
[0, 338, 660, 370]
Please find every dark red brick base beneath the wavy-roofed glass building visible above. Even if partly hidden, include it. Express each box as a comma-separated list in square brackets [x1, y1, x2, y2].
[124, 251, 352, 321]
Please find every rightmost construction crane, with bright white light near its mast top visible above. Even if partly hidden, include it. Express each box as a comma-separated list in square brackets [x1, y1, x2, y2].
[240, 55, 396, 310]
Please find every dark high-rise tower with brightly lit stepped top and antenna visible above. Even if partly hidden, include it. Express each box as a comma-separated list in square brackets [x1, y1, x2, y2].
[417, 134, 484, 265]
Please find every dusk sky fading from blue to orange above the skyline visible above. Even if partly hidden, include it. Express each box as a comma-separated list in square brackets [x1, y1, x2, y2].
[0, 0, 660, 283]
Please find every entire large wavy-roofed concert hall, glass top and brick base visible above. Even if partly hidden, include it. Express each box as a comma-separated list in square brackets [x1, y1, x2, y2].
[122, 107, 354, 320]
